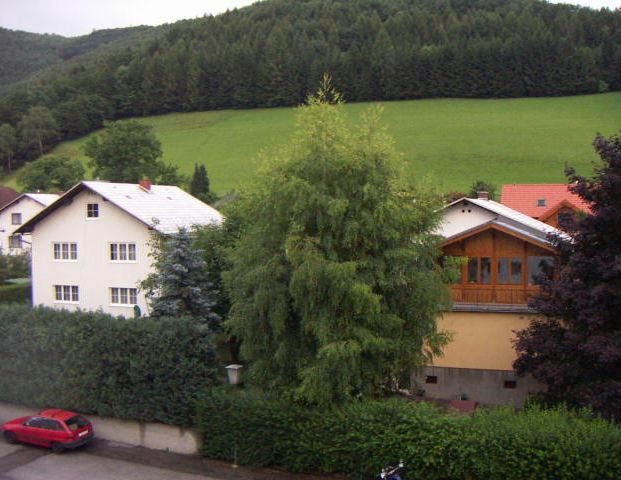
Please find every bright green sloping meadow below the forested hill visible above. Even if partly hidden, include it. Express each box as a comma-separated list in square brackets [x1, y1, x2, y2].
[4, 92, 621, 194]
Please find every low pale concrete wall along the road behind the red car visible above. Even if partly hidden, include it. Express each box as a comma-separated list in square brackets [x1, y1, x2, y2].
[0, 402, 199, 455]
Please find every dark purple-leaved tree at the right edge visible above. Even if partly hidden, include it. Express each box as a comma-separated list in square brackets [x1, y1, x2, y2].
[515, 134, 621, 420]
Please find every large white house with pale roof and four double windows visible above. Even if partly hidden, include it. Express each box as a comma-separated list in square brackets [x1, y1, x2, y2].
[18, 181, 223, 317]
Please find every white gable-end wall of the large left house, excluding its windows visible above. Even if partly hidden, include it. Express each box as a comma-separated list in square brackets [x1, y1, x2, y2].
[31, 191, 151, 317]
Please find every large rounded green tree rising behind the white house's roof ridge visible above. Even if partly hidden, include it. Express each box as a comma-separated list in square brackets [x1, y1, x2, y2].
[84, 120, 175, 183]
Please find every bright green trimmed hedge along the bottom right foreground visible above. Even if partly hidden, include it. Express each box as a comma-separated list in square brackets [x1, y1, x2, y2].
[197, 388, 621, 480]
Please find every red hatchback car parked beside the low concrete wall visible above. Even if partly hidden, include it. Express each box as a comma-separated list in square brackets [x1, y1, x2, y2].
[2, 408, 93, 453]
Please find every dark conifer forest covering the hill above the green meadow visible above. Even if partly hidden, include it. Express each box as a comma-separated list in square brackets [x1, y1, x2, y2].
[0, 0, 621, 171]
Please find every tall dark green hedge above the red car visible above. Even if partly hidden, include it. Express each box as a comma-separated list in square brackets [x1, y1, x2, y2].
[0, 305, 216, 426]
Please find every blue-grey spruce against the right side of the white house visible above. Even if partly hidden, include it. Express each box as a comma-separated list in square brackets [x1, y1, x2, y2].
[140, 228, 220, 330]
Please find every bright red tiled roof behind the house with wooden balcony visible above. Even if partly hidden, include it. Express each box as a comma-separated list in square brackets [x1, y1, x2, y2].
[500, 183, 591, 218]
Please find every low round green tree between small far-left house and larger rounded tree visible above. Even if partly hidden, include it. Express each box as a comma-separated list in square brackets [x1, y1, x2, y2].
[17, 156, 85, 192]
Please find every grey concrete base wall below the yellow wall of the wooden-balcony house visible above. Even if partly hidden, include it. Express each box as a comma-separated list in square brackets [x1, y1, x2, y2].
[412, 367, 545, 407]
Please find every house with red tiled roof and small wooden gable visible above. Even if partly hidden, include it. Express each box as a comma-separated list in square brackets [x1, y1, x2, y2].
[500, 183, 591, 228]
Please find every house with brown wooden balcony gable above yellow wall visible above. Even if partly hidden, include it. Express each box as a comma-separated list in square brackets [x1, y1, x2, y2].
[415, 195, 562, 406]
